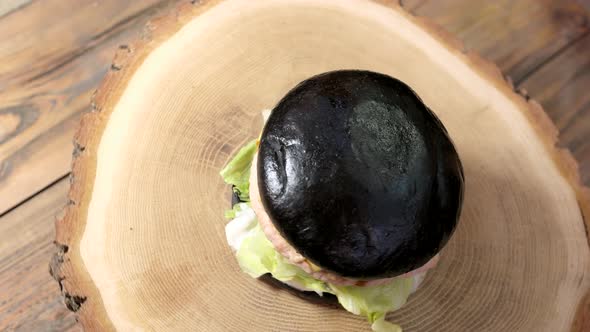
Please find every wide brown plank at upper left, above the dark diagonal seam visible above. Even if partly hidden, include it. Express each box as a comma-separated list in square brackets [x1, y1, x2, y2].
[0, 0, 180, 214]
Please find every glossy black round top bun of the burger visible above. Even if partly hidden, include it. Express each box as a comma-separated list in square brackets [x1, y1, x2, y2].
[258, 70, 463, 279]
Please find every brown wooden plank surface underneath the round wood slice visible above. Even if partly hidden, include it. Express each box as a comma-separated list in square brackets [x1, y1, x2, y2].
[0, 0, 590, 331]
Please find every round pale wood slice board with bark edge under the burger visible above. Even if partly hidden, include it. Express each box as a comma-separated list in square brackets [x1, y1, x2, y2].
[51, 0, 590, 331]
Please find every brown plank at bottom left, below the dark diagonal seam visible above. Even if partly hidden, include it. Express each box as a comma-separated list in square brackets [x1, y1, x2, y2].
[0, 179, 81, 332]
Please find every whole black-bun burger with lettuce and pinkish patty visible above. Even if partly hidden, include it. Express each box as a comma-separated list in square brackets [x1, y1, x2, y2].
[221, 70, 464, 331]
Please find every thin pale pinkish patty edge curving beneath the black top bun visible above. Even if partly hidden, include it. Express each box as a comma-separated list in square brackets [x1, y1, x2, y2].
[250, 154, 439, 286]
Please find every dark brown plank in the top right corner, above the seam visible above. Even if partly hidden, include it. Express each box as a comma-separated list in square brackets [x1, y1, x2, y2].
[414, 0, 590, 83]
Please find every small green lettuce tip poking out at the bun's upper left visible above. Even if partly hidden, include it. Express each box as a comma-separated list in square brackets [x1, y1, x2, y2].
[219, 140, 258, 202]
